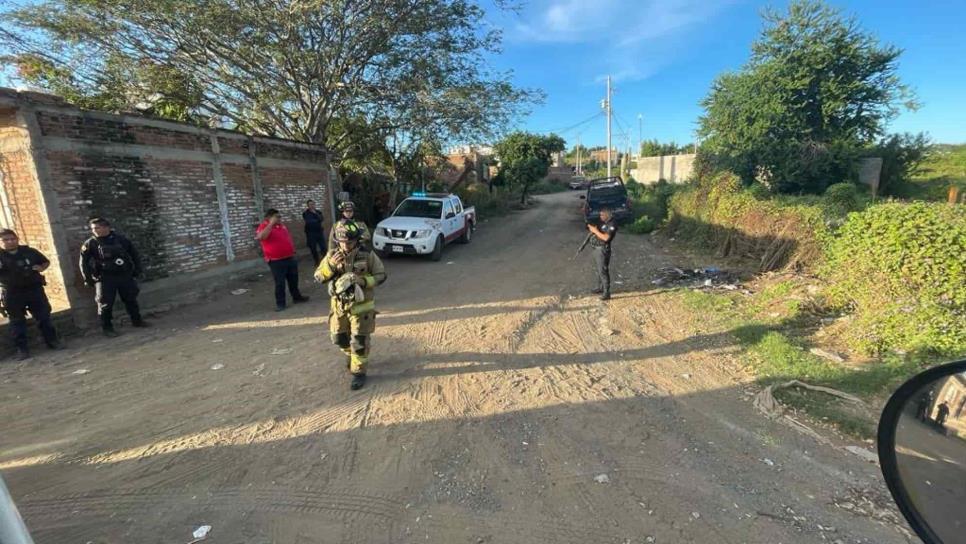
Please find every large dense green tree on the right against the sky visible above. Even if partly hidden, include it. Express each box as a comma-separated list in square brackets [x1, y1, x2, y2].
[699, 0, 916, 193]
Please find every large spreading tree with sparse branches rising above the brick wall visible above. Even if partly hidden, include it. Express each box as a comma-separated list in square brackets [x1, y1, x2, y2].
[0, 0, 540, 193]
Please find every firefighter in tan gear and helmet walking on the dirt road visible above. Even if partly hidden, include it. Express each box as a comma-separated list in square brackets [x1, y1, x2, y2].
[315, 220, 386, 390]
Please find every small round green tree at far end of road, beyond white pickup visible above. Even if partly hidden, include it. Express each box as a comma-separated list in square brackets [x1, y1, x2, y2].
[494, 132, 567, 204]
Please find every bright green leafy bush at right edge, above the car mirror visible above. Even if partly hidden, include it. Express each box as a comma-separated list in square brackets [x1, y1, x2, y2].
[823, 202, 966, 356]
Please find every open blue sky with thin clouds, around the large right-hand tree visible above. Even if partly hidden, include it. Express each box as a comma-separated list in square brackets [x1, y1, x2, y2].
[488, 0, 966, 147]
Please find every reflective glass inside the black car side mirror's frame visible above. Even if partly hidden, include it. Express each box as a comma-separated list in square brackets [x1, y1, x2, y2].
[895, 372, 966, 543]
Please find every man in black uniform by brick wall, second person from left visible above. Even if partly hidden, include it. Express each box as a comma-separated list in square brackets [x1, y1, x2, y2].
[80, 217, 147, 338]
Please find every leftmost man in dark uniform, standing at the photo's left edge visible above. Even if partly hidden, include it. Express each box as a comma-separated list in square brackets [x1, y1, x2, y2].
[0, 229, 62, 361]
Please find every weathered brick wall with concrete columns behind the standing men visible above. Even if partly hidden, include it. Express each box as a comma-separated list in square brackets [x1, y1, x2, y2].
[0, 89, 330, 328]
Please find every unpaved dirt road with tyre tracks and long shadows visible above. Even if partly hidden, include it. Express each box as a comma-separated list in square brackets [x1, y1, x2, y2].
[0, 193, 909, 544]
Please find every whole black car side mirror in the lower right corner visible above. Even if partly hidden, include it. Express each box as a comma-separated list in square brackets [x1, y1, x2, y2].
[878, 360, 966, 544]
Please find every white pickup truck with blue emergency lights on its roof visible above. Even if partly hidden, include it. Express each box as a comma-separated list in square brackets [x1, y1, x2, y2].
[372, 193, 476, 261]
